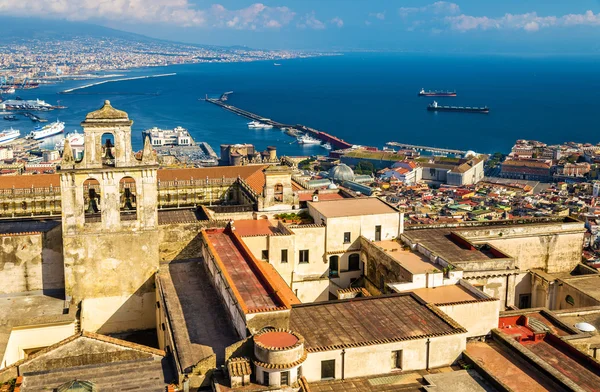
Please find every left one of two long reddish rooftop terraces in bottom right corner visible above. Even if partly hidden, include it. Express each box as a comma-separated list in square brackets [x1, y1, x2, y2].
[466, 341, 566, 392]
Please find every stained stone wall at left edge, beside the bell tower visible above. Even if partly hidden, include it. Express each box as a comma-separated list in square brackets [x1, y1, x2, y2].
[0, 225, 64, 294]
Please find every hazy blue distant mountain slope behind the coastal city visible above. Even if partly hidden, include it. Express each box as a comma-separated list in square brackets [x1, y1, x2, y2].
[0, 16, 183, 44]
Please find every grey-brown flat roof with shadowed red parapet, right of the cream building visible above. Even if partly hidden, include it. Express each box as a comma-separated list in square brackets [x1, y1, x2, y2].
[402, 229, 508, 262]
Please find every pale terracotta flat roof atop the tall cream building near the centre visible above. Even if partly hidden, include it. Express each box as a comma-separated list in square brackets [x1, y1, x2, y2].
[308, 197, 398, 218]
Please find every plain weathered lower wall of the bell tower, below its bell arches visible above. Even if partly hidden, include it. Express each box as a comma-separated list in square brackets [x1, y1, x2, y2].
[64, 230, 159, 333]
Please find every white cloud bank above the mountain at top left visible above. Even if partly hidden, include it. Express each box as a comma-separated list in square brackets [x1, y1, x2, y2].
[0, 0, 295, 29]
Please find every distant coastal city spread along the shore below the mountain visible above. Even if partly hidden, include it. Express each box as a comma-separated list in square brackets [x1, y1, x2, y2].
[0, 37, 319, 82]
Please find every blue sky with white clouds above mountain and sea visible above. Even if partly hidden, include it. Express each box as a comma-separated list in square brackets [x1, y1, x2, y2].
[0, 0, 600, 53]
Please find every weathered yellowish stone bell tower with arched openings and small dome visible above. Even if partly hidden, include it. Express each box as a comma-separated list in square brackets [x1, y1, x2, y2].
[60, 101, 159, 333]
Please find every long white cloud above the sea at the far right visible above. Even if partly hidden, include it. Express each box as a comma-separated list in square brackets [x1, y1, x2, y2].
[445, 11, 600, 32]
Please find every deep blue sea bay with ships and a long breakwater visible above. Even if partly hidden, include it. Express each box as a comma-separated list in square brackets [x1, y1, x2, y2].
[7, 53, 600, 155]
